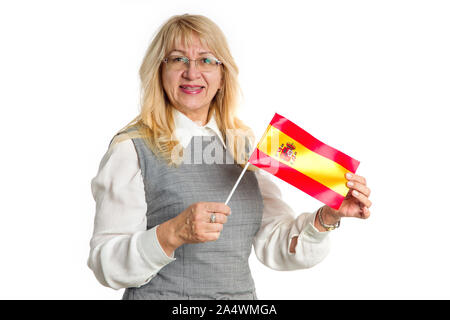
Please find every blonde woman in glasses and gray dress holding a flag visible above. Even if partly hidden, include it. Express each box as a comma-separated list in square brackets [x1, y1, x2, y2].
[88, 15, 371, 299]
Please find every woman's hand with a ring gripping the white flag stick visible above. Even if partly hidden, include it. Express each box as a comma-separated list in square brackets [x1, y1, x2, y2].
[156, 202, 231, 256]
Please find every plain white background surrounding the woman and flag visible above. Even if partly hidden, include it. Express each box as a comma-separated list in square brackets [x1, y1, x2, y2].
[0, 0, 450, 299]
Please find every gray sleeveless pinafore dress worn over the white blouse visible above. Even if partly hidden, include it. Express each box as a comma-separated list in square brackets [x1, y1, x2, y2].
[123, 132, 263, 300]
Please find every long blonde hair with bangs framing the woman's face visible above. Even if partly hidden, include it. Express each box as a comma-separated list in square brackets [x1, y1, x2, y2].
[113, 14, 256, 170]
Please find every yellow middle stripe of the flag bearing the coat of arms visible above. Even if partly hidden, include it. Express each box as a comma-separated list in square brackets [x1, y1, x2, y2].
[257, 125, 350, 197]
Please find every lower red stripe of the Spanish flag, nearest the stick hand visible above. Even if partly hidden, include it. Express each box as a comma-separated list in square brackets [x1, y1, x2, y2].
[249, 148, 345, 210]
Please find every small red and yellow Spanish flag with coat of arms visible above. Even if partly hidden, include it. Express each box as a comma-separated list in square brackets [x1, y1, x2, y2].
[249, 113, 359, 210]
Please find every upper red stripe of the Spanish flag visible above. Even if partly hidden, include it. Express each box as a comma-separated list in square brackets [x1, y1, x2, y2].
[270, 113, 359, 173]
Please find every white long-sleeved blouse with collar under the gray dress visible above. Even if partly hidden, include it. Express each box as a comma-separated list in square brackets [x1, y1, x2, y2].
[88, 109, 330, 289]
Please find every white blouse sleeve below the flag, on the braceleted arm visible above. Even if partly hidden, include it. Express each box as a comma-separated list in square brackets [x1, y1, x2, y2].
[253, 170, 330, 270]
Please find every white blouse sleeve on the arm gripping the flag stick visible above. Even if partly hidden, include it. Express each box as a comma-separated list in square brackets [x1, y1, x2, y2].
[88, 140, 175, 289]
